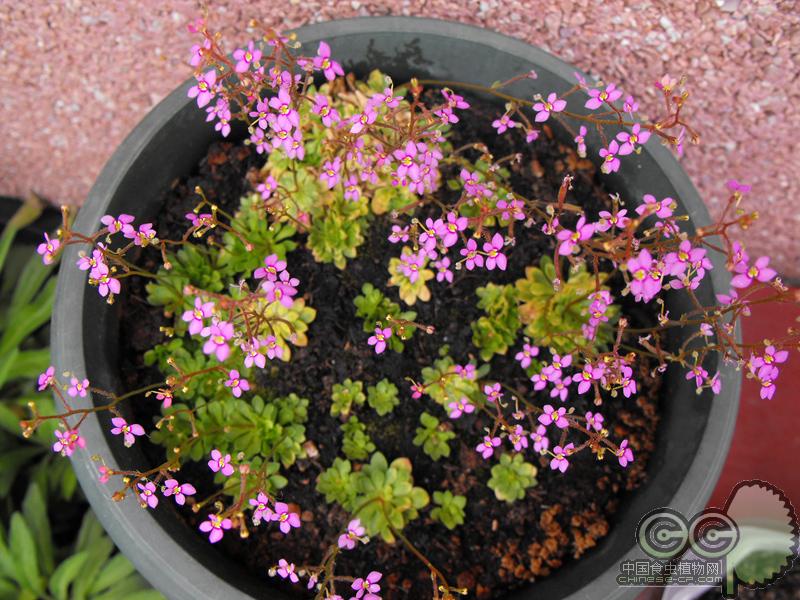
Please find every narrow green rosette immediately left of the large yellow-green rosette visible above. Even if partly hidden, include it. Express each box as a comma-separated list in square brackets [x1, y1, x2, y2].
[472, 283, 522, 360]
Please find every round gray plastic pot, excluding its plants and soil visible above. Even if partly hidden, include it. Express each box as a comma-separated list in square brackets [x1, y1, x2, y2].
[52, 17, 740, 600]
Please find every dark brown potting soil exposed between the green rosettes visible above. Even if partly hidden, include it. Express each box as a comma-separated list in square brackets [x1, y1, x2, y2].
[120, 99, 659, 600]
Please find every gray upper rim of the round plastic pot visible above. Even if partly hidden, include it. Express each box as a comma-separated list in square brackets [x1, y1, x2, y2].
[51, 17, 741, 600]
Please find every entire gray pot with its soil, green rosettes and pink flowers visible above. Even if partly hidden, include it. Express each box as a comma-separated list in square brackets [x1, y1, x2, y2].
[31, 18, 796, 598]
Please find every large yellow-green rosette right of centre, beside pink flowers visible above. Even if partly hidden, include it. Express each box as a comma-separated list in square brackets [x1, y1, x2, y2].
[514, 256, 619, 354]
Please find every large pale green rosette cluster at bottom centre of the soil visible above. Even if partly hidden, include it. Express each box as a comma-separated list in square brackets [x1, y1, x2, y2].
[317, 452, 430, 543]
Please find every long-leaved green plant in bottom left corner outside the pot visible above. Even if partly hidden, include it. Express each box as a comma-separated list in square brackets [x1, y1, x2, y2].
[0, 483, 162, 600]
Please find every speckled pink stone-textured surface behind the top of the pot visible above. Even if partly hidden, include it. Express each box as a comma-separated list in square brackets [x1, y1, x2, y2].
[0, 0, 800, 277]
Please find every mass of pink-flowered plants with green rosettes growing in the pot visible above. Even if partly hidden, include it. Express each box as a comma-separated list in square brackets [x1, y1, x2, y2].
[28, 14, 798, 600]
